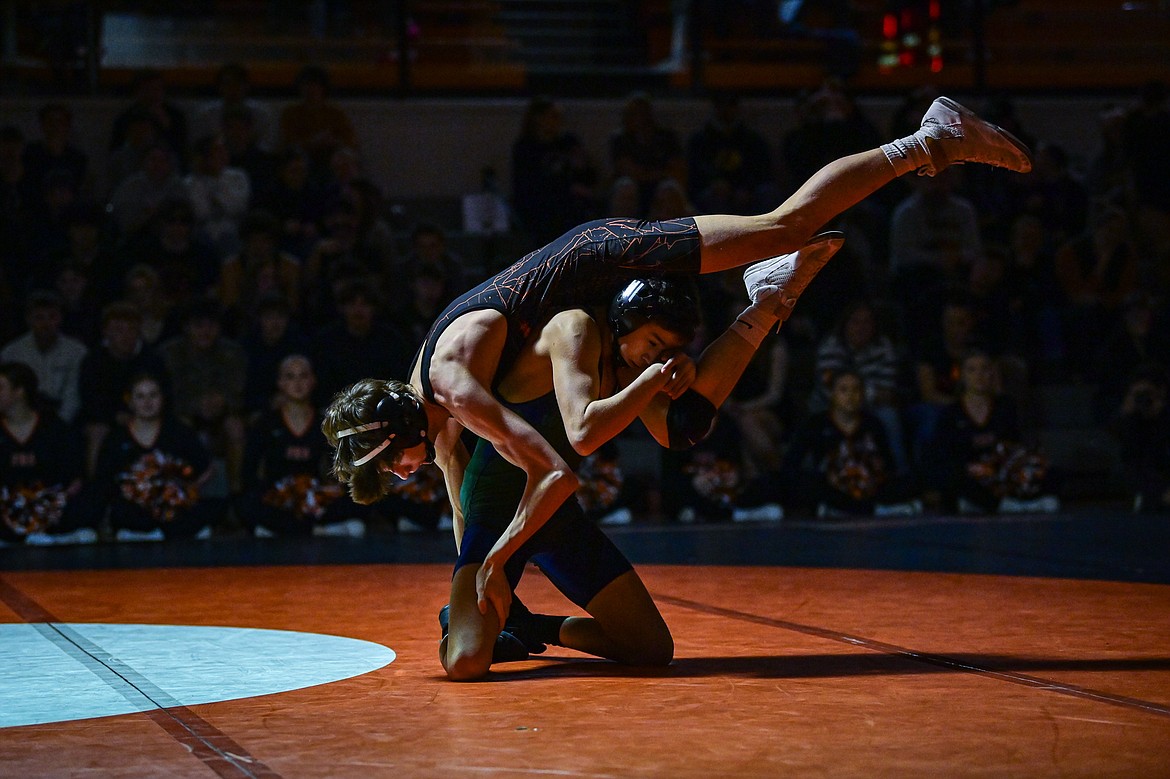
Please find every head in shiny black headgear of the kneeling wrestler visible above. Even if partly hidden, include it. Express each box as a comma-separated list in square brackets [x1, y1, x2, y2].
[608, 277, 700, 368]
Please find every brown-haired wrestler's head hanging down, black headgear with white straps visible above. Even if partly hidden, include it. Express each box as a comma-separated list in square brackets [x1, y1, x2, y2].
[321, 379, 434, 504]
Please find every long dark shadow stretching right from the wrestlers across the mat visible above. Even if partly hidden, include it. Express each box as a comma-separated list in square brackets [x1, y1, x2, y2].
[491, 653, 1170, 680]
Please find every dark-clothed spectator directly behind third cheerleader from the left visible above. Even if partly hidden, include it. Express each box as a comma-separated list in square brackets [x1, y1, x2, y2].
[241, 290, 309, 419]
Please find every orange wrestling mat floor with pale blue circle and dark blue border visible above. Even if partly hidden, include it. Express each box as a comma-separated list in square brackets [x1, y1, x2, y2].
[0, 510, 1170, 778]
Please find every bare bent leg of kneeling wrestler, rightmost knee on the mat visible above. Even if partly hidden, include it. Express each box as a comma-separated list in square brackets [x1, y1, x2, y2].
[560, 563, 674, 666]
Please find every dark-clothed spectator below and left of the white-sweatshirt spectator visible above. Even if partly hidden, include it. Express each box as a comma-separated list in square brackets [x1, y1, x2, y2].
[125, 198, 221, 308]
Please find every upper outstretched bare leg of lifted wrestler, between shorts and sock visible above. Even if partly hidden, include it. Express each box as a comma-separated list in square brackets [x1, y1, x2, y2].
[695, 149, 897, 274]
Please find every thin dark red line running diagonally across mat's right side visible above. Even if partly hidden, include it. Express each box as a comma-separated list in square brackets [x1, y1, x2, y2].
[654, 593, 1170, 717]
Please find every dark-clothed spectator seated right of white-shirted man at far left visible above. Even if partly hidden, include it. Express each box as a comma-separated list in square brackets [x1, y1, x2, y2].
[77, 301, 166, 473]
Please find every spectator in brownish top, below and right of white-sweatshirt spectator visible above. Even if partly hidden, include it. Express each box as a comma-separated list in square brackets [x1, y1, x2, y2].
[219, 205, 301, 331]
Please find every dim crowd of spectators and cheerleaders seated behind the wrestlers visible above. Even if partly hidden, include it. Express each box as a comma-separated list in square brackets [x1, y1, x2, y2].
[0, 64, 1170, 544]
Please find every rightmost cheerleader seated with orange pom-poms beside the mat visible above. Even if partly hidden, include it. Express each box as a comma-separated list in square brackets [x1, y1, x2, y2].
[922, 347, 1060, 513]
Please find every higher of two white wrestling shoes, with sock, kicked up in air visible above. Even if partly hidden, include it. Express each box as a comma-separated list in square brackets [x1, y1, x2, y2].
[915, 97, 1032, 175]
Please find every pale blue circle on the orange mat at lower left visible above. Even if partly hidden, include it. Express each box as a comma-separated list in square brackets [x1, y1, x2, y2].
[0, 622, 395, 728]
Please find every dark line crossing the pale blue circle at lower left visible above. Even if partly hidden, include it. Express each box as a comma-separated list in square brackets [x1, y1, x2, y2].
[0, 577, 281, 779]
